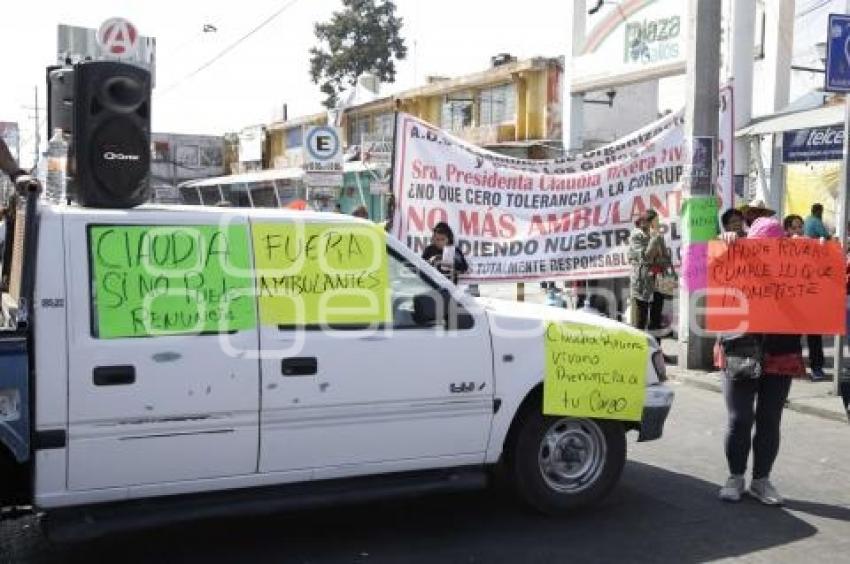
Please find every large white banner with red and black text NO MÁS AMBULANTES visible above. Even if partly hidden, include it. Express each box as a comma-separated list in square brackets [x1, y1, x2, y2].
[393, 113, 728, 282]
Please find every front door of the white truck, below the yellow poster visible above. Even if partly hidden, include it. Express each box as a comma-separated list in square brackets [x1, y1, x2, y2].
[252, 226, 494, 479]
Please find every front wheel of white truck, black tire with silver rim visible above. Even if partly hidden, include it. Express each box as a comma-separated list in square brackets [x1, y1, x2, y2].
[510, 410, 626, 514]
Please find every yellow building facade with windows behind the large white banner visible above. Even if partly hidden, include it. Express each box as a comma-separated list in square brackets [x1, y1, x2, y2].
[265, 55, 563, 164]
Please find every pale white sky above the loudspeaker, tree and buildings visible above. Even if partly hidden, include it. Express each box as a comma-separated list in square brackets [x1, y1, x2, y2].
[0, 0, 569, 166]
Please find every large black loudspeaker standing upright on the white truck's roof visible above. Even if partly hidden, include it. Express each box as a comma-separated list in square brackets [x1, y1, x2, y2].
[70, 61, 151, 208]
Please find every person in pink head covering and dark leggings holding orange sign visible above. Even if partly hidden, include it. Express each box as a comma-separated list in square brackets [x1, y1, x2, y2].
[720, 217, 805, 505]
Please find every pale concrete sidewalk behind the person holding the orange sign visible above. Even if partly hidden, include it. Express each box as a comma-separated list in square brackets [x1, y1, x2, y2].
[661, 339, 848, 423]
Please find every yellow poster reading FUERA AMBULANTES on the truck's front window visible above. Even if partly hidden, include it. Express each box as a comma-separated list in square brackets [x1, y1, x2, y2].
[252, 223, 391, 326]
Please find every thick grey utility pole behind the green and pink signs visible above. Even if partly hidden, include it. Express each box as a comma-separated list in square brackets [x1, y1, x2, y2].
[679, 0, 722, 369]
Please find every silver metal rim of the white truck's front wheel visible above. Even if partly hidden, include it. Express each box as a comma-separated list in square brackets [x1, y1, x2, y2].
[537, 419, 607, 493]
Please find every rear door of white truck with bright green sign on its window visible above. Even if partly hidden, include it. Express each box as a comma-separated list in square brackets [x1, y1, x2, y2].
[64, 214, 259, 490]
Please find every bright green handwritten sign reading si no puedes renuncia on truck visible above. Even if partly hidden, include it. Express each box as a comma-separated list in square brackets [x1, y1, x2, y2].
[89, 225, 256, 339]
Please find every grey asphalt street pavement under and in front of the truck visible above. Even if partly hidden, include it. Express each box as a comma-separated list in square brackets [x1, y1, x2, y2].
[0, 383, 850, 564]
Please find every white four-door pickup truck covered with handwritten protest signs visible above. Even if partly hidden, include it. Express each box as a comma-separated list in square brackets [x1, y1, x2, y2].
[0, 198, 673, 539]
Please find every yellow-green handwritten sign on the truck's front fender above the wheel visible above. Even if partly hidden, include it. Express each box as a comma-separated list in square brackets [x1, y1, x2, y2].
[543, 322, 649, 421]
